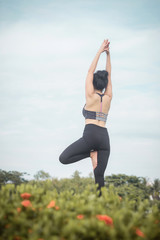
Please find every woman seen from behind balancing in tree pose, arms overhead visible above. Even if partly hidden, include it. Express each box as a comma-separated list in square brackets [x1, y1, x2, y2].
[59, 39, 112, 196]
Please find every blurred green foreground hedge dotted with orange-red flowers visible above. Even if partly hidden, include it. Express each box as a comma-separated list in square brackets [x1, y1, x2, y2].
[0, 180, 160, 240]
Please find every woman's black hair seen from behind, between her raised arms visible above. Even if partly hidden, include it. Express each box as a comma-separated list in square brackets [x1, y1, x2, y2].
[93, 70, 108, 91]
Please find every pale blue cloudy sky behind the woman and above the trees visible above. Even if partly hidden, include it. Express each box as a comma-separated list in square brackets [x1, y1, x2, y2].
[0, 0, 160, 179]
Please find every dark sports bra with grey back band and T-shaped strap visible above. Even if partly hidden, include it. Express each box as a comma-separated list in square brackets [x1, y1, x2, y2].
[82, 92, 108, 122]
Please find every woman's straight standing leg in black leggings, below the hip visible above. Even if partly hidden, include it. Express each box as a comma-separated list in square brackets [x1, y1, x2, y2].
[94, 150, 110, 196]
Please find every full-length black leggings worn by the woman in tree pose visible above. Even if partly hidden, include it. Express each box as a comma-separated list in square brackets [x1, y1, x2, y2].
[59, 124, 110, 196]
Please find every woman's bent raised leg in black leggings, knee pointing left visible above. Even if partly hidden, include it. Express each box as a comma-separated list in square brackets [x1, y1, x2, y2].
[59, 137, 91, 164]
